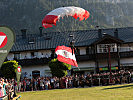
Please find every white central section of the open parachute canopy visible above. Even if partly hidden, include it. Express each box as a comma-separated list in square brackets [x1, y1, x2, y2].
[47, 6, 85, 18]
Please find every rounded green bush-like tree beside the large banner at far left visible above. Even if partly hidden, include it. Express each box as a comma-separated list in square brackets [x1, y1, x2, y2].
[0, 60, 18, 78]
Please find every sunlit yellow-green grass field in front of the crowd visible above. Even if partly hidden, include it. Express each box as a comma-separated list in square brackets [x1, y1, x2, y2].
[19, 84, 133, 100]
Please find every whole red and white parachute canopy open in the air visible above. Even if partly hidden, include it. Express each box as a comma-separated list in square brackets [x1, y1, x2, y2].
[42, 6, 90, 28]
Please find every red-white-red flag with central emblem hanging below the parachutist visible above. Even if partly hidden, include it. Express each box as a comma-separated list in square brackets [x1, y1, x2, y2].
[55, 46, 78, 67]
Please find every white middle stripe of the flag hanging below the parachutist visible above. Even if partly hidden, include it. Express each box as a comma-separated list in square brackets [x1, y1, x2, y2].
[55, 50, 76, 61]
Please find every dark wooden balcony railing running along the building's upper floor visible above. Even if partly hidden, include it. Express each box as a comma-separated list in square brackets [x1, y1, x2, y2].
[5, 51, 133, 66]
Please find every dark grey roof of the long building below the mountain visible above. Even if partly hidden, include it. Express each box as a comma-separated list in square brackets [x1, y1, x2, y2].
[11, 27, 133, 52]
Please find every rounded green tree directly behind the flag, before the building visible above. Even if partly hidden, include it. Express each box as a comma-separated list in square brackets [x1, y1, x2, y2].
[49, 59, 71, 78]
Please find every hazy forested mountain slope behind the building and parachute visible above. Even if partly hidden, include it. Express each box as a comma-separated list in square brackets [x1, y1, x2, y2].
[0, 0, 133, 34]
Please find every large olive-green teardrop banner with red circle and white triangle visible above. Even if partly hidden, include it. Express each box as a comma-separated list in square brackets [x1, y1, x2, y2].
[0, 26, 15, 68]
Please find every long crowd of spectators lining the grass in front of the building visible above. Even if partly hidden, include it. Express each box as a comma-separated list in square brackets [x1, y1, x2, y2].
[18, 70, 133, 91]
